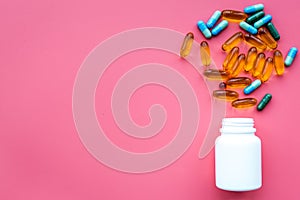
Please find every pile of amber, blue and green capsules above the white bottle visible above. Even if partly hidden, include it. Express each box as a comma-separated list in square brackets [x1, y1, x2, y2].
[180, 4, 298, 111]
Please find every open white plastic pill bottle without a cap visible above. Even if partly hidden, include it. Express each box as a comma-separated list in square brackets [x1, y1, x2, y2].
[215, 118, 262, 192]
